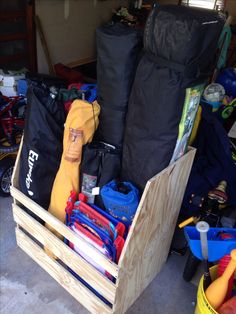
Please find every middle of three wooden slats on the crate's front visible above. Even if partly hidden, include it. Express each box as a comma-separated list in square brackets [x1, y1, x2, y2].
[12, 204, 116, 303]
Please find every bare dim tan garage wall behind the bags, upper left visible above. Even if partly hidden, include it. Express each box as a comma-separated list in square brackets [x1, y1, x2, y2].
[35, 0, 128, 73]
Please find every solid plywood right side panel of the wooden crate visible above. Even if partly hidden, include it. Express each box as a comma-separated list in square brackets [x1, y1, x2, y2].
[114, 149, 195, 314]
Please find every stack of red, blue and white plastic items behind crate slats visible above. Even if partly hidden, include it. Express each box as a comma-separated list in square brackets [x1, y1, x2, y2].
[65, 191, 125, 264]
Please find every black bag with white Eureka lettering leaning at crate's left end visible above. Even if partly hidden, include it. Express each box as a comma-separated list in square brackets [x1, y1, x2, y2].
[19, 86, 65, 215]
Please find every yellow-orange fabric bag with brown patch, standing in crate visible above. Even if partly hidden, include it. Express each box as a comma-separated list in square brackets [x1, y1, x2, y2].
[49, 100, 100, 237]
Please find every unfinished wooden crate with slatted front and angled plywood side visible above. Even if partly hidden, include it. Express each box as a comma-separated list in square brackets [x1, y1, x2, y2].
[11, 148, 195, 314]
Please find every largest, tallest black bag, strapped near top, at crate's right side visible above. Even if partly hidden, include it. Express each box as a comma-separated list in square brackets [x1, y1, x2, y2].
[121, 5, 224, 189]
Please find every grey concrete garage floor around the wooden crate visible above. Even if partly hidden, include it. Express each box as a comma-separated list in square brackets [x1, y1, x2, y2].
[0, 197, 197, 314]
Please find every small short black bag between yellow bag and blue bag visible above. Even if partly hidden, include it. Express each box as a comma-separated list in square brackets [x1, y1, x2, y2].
[80, 142, 121, 208]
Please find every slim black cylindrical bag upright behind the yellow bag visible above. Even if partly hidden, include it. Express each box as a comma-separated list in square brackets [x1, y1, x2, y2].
[95, 24, 142, 147]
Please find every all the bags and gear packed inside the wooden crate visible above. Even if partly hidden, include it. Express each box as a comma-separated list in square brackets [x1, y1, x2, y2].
[19, 6, 223, 290]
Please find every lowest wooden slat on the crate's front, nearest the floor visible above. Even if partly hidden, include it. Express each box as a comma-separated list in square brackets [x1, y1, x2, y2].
[16, 228, 112, 314]
